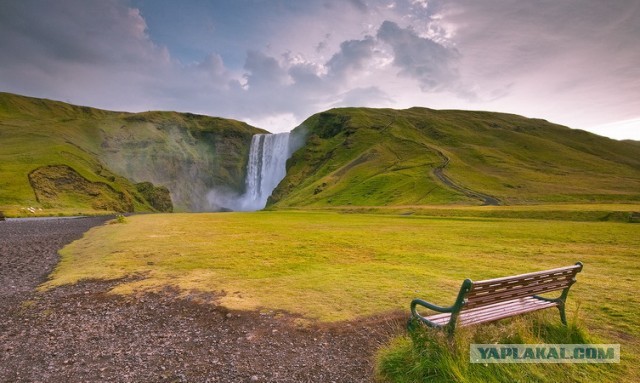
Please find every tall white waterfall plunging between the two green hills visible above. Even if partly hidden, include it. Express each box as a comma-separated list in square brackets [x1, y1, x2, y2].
[240, 133, 291, 210]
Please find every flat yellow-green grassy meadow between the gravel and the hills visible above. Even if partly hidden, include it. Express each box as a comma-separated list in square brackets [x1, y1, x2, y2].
[42, 205, 640, 381]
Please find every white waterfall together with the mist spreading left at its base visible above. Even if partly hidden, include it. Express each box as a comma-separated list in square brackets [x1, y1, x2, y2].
[207, 133, 302, 211]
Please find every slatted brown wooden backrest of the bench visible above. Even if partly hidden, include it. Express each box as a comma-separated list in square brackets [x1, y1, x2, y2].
[462, 263, 582, 310]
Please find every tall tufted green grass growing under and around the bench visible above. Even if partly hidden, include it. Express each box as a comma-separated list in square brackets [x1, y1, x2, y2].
[376, 313, 623, 383]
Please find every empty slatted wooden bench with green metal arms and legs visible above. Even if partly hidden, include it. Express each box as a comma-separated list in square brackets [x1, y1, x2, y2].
[410, 262, 582, 334]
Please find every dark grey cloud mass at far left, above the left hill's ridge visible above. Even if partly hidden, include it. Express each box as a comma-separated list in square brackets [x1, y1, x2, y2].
[0, 0, 173, 109]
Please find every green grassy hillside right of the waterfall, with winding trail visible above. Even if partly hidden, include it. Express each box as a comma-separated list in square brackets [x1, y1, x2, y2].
[270, 108, 640, 207]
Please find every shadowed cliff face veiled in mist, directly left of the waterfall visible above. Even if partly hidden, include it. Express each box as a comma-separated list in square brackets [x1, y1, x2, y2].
[99, 112, 262, 211]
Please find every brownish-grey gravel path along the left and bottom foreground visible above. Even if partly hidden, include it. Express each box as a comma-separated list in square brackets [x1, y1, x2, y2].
[0, 218, 404, 383]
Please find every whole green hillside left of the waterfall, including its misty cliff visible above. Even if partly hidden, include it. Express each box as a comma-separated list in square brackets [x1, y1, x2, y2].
[0, 93, 262, 215]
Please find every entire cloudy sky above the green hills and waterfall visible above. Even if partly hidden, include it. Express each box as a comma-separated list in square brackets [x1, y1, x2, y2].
[0, 0, 640, 140]
